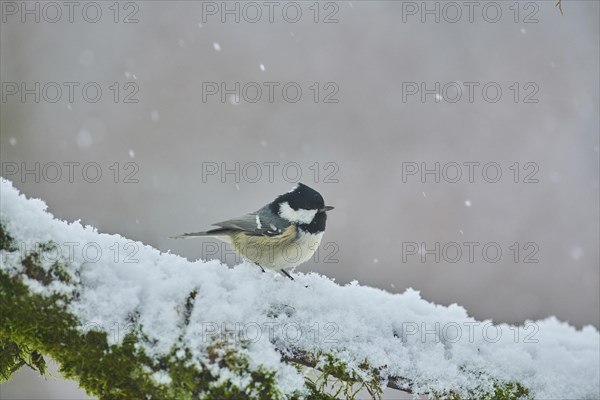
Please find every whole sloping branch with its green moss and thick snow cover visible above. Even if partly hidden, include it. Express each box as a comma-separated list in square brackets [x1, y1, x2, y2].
[0, 180, 600, 399]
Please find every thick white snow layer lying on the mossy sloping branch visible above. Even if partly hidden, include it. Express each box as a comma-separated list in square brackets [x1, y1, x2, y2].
[0, 179, 600, 399]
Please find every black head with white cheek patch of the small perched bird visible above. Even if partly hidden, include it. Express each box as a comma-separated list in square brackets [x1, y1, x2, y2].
[269, 183, 333, 233]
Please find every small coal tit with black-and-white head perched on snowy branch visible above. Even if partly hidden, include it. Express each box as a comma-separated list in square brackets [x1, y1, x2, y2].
[171, 183, 333, 280]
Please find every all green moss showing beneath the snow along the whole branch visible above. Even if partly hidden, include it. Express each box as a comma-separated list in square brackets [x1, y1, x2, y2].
[0, 220, 528, 400]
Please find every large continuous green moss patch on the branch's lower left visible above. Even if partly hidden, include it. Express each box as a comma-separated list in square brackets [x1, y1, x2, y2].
[0, 225, 281, 399]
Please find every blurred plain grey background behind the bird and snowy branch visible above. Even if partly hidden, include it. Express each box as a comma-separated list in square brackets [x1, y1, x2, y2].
[0, 1, 600, 398]
